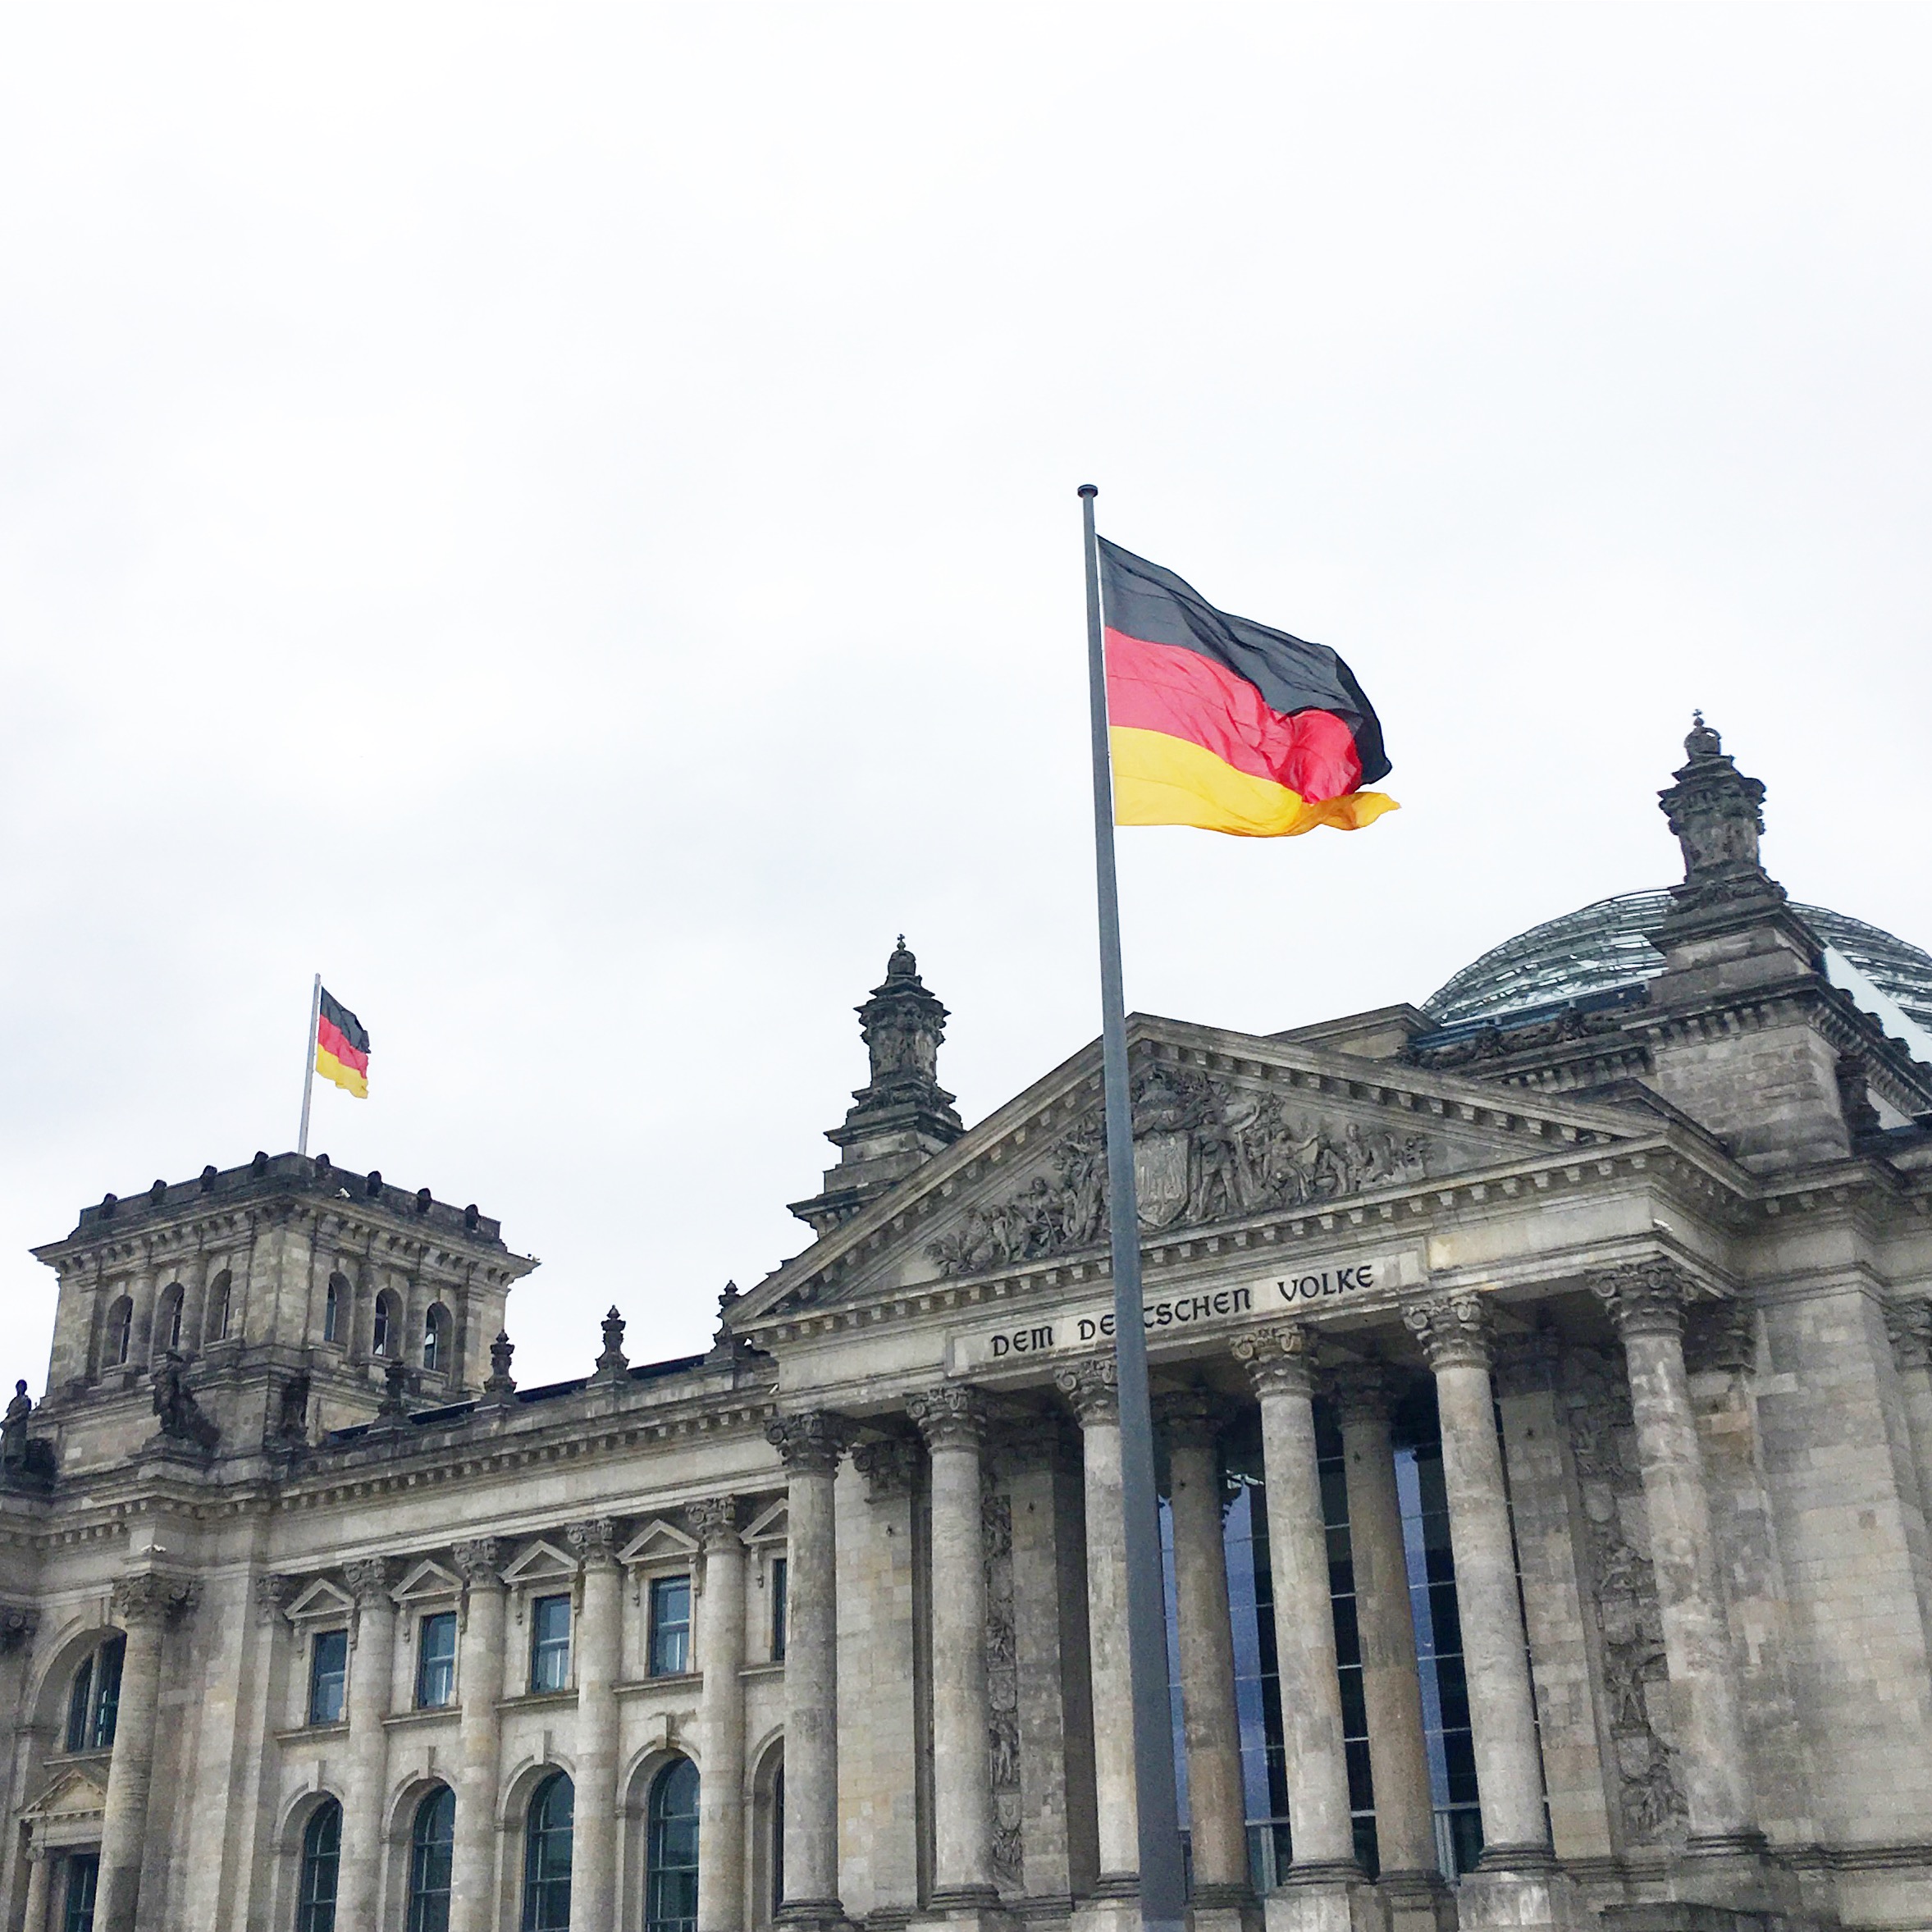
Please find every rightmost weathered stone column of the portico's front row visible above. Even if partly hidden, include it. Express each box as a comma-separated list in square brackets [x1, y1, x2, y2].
[1590, 1259, 1762, 1852]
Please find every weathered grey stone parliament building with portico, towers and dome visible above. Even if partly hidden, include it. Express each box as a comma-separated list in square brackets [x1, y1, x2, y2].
[0, 724, 1932, 1932]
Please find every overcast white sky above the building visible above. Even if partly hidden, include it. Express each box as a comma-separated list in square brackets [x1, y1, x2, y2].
[0, 4, 1932, 1393]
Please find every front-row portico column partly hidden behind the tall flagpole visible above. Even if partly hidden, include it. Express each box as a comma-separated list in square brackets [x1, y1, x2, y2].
[1053, 1359, 1140, 1898]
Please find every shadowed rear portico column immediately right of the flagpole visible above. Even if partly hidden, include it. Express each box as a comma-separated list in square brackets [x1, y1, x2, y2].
[1161, 1389, 1248, 1932]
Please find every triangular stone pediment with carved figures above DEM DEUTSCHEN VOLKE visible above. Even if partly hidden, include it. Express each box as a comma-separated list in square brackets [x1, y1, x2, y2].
[734, 1014, 1656, 1327]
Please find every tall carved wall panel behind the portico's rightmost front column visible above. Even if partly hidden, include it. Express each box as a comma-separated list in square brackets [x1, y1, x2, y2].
[1559, 1349, 1685, 1845]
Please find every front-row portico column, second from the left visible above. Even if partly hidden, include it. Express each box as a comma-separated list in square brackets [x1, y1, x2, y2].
[906, 1383, 999, 1912]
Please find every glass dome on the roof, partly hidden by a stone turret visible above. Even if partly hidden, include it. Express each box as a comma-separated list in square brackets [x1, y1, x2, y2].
[1422, 891, 1932, 1028]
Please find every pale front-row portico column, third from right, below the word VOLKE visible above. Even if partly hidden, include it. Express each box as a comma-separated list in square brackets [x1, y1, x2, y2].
[1235, 1322, 1362, 1879]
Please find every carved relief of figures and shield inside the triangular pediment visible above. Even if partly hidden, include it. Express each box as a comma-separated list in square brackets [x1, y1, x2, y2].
[925, 1066, 1427, 1275]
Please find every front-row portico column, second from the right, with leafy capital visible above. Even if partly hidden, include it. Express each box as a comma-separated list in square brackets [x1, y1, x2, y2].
[1403, 1295, 1550, 1868]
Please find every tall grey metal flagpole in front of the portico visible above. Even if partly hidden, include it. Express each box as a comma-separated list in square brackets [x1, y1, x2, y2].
[1080, 483, 1186, 1932]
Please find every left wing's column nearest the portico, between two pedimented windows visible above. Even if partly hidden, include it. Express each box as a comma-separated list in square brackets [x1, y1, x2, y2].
[690, 1496, 746, 1932]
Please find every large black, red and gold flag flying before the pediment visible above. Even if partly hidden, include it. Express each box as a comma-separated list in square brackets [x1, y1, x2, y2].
[1099, 537, 1395, 838]
